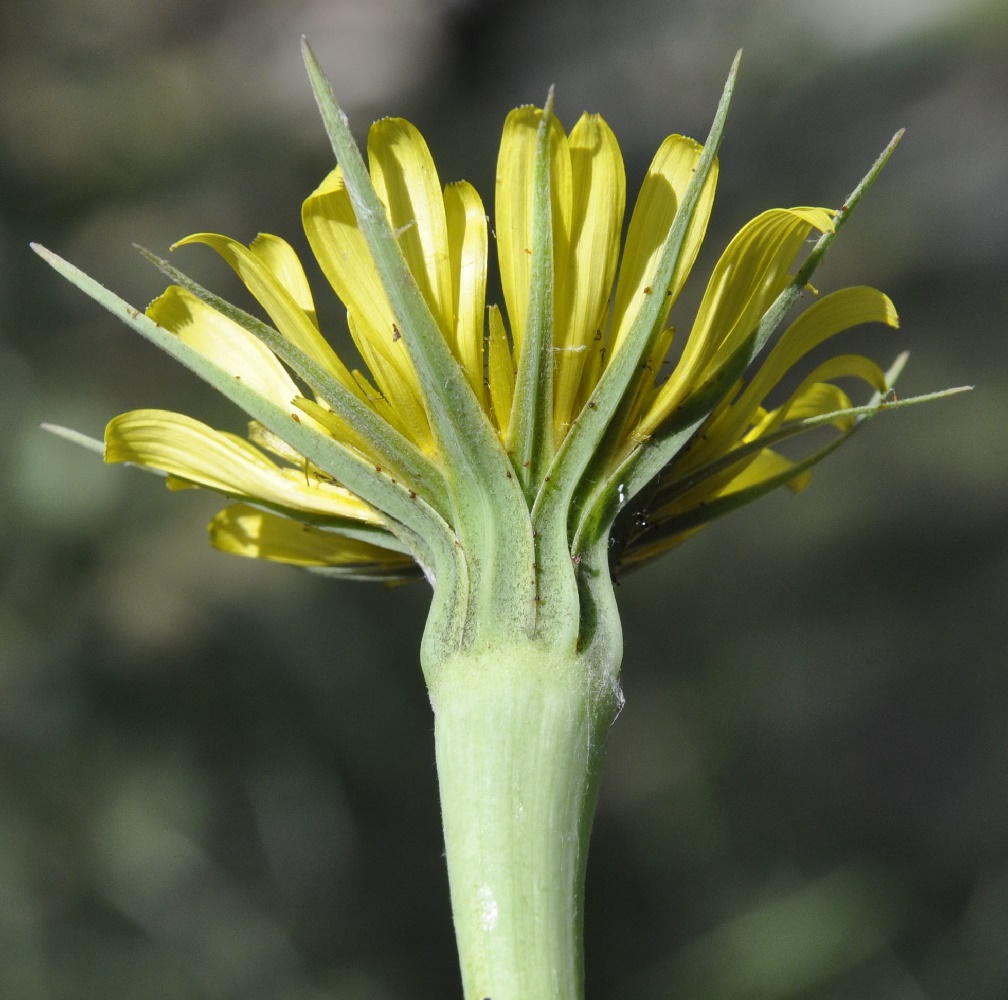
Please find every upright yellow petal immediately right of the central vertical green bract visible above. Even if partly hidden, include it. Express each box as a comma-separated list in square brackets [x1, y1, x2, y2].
[553, 114, 626, 446]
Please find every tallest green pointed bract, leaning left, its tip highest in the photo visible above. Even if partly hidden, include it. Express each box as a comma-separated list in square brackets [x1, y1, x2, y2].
[301, 38, 535, 645]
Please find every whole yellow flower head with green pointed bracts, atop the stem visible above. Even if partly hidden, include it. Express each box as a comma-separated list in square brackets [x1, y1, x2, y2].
[33, 49, 959, 673]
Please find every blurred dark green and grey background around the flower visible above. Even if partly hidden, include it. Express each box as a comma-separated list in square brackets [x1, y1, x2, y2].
[0, 0, 1008, 1000]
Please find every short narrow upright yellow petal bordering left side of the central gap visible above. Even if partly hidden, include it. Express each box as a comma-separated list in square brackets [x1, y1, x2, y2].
[445, 180, 487, 407]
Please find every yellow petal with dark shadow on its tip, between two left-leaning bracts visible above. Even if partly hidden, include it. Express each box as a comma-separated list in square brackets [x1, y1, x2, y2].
[147, 285, 300, 407]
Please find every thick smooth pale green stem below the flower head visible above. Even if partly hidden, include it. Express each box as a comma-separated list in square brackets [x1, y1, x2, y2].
[430, 641, 619, 1000]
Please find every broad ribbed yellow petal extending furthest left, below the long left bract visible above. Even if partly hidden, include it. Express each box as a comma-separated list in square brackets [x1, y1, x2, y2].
[105, 409, 384, 524]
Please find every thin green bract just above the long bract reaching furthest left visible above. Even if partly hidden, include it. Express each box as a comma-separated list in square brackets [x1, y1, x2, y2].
[137, 247, 450, 519]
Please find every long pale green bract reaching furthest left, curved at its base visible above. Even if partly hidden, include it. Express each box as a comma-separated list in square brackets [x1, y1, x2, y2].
[32, 244, 468, 665]
